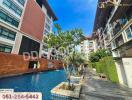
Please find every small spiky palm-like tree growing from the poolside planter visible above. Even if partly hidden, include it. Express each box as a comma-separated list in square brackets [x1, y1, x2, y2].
[63, 51, 85, 87]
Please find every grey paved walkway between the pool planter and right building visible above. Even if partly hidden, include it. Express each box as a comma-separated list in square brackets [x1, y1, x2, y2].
[80, 69, 132, 100]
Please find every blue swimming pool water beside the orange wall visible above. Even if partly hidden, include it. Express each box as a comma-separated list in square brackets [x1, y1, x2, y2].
[0, 70, 66, 100]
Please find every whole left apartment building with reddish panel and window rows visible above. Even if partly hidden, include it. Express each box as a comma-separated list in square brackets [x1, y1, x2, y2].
[0, 0, 57, 57]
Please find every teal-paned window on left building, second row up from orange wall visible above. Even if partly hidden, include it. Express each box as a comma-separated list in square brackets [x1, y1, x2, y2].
[0, 26, 16, 41]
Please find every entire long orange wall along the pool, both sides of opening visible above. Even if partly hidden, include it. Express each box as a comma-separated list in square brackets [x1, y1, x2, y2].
[0, 53, 62, 77]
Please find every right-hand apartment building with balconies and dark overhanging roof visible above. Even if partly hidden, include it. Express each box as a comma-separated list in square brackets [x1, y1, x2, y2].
[93, 0, 132, 88]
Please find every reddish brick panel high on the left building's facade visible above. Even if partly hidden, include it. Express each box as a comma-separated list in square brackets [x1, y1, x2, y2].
[20, 0, 45, 40]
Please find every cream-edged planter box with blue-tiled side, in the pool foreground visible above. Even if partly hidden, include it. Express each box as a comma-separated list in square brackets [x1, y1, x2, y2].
[51, 82, 81, 100]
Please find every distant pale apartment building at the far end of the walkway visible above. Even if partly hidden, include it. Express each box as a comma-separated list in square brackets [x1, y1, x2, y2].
[79, 37, 95, 60]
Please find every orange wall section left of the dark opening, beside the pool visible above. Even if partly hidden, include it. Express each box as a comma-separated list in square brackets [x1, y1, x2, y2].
[0, 53, 28, 76]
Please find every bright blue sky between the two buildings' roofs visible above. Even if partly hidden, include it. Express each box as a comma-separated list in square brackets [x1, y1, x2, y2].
[48, 0, 97, 36]
